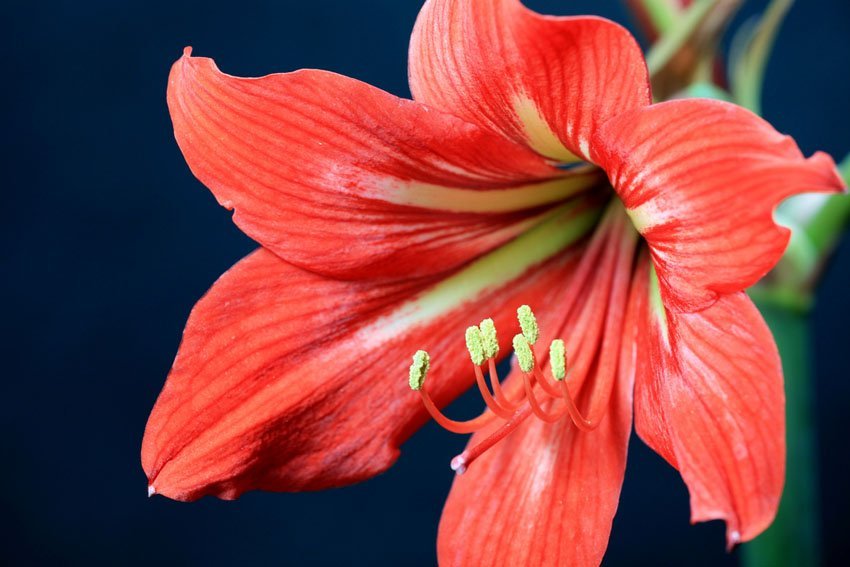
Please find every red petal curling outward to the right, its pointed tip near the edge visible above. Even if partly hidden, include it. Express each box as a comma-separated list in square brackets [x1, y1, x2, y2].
[593, 99, 844, 311]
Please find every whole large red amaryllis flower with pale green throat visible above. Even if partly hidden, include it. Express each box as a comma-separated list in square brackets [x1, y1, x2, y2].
[142, 0, 842, 565]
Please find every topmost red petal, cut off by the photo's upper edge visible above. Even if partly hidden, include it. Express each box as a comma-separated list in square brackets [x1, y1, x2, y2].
[410, 0, 650, 161]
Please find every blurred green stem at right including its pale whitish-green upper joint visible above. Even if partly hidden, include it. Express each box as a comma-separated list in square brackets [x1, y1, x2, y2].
[742, 156, 850, 567]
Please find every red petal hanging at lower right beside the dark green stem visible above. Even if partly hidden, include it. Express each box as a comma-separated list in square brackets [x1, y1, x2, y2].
[635, 276, 785, 546]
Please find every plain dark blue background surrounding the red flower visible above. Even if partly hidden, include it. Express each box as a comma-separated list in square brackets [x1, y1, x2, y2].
[0, 0, 850, 565]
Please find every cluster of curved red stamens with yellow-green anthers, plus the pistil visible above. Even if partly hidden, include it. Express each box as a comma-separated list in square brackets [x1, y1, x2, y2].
[409, 305, 602, 474]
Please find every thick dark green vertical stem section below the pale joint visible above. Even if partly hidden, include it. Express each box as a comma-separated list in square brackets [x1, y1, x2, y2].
[742, 300, 820, 567]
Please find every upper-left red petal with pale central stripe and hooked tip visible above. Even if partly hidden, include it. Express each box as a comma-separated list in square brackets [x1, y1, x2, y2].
[168, 50, 595, 278]
